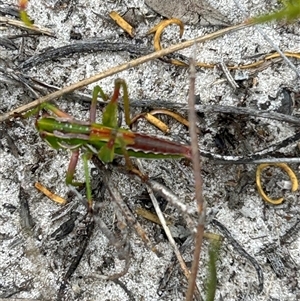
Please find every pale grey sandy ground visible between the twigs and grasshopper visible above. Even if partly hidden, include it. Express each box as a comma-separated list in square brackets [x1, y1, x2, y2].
[0, 0, 300, 301]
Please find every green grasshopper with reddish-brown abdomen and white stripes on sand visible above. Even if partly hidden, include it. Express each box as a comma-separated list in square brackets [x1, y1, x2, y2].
[31, 79, 191, 212]
